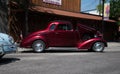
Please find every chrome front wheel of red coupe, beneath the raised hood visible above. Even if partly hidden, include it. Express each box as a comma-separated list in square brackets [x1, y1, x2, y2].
[91, 42, 105, 52]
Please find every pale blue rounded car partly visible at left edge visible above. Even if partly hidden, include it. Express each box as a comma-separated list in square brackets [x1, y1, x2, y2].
[0, 33, 17, 58]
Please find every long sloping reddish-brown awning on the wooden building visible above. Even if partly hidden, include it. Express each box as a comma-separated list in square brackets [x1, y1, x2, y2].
[31, 6, 115, 22]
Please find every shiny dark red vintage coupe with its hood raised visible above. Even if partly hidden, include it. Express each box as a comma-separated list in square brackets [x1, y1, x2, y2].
[20, 21, 107, 52]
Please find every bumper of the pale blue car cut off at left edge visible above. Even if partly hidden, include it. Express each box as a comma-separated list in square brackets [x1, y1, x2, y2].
[0, 44, 17, 55]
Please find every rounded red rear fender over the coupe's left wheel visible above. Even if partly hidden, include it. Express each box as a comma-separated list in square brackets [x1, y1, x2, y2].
[20, 36, 46, 47]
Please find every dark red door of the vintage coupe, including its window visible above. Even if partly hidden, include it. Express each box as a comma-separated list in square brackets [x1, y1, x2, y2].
[55, 24, 75, 46]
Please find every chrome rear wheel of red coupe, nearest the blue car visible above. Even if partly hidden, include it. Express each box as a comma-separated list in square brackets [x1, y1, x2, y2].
[32, 40, 45, 53]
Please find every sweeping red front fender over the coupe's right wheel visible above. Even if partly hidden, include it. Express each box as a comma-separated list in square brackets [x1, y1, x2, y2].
[77, 38, 107, 49]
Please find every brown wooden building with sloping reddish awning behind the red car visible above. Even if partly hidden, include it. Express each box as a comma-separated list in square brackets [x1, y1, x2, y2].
[10, 0, 118, 41]
